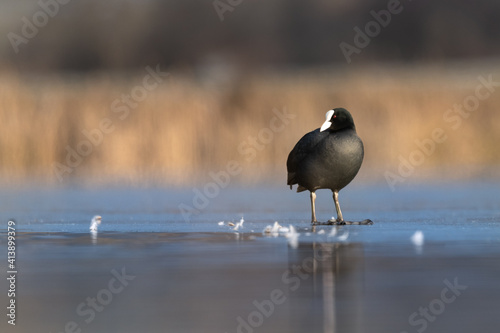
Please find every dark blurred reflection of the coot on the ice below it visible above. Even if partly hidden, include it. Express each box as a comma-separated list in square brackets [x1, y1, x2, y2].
[287, 243, 364, 332]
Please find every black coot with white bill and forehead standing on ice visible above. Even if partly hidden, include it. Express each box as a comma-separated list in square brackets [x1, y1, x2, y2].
[286, 108, 372, 224]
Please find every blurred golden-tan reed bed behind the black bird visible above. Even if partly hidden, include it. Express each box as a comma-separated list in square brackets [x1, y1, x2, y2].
[0, 63, 500, 186]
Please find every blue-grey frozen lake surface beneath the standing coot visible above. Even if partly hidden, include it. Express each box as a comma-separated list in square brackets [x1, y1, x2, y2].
[0, 182, 500, 333]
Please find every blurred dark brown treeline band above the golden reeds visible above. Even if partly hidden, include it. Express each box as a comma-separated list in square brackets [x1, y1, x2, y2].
[0, 0, 500, 71]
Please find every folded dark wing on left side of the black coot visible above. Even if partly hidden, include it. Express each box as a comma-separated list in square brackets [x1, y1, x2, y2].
[286, 128, 328, 186]
